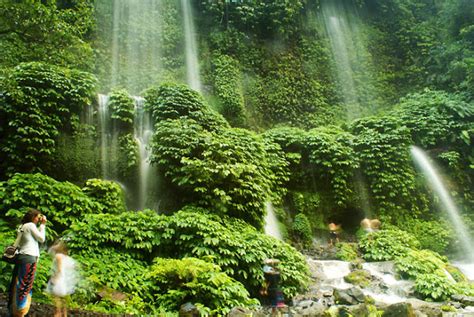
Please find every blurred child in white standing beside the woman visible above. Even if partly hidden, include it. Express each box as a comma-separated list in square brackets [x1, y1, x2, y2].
[46, 241, 78, 317]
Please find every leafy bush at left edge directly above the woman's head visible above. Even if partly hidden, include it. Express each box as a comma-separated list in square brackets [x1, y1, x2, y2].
[0, 173, 104, 234]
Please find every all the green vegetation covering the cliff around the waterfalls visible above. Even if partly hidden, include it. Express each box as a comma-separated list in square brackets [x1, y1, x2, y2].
[0, 0, 474, 314]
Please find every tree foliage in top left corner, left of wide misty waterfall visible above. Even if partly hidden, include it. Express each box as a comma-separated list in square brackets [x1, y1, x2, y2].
[0, 0, 94, 71]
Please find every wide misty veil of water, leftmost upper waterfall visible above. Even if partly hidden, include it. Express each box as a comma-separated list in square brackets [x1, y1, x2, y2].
[96, 0, 162, 93]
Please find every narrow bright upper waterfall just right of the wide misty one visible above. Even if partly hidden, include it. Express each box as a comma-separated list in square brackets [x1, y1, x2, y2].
[181, 0, 201, 92]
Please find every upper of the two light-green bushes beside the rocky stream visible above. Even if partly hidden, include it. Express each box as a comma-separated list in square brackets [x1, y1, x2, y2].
[359, 229, 420, 261]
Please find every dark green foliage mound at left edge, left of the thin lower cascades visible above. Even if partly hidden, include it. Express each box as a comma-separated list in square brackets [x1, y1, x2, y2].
[0, 63, 95, 177]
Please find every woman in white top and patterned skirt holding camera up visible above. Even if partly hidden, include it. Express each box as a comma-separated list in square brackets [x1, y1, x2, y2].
[8, 209, 46, 317]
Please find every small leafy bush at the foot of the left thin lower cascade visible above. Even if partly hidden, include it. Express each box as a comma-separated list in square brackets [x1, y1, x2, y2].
[82, 178, 126, 213]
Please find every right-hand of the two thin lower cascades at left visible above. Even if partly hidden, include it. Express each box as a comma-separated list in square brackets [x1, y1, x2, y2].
[134, 97, 153, 210]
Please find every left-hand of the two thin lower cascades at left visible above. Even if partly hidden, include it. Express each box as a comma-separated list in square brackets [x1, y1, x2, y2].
[98, 94, 110, 179]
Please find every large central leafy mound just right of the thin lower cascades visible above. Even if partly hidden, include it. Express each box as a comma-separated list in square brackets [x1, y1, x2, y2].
[151, 119, 287, 228]
